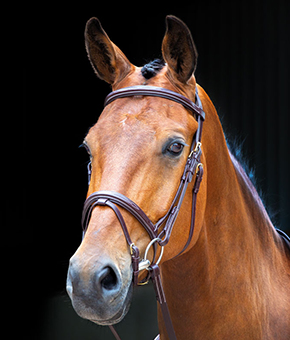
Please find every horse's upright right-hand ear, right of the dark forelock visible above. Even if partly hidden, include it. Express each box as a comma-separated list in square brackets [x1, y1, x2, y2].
[162, 15, 197, 83]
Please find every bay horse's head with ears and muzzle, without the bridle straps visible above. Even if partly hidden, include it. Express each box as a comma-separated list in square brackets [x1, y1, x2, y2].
[67, 16, 206, 325]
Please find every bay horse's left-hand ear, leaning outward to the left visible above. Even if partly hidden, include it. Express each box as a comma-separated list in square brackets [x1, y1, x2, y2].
[85, 18, 133, 85]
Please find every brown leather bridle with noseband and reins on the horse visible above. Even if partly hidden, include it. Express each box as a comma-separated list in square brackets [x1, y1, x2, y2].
[82, 85, 205, 340]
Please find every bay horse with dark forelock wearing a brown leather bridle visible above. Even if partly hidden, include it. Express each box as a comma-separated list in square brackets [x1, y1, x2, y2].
[67, 16, 290, 340]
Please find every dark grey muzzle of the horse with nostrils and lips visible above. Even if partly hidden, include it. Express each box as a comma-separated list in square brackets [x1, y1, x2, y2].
[66, 254, 133, 325]
